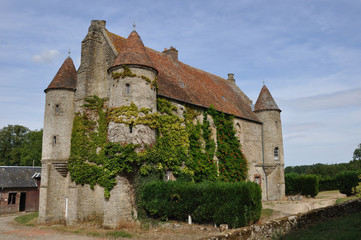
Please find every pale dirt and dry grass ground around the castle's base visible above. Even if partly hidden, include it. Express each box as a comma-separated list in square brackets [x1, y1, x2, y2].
[0, 191, 352, 240]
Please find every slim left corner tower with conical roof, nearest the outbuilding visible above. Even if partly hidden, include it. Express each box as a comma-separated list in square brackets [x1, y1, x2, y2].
[39, 57, 77, 222]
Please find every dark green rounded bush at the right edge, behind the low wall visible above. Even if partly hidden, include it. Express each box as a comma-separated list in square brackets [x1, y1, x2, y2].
[336, 171, 361, 196]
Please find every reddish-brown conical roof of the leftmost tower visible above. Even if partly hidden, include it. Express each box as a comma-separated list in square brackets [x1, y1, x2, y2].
[44, 57, 76, 92]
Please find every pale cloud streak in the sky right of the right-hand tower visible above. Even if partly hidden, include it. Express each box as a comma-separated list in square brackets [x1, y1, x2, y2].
[284, 88, 361, 111]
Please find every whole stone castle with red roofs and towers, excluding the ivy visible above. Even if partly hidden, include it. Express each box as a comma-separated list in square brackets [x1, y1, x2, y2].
[39, 20, 285, 227]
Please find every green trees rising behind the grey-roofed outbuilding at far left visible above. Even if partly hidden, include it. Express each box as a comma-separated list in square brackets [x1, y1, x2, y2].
[0, 125, 43, 166]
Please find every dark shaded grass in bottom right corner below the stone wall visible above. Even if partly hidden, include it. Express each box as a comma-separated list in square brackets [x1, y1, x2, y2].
[278, 212, 361, 240]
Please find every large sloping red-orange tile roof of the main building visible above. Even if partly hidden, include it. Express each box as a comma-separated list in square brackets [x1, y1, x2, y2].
[107, 32, 260, 122]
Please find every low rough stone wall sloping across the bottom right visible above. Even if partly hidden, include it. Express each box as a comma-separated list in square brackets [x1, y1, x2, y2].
[203, 199, 361, 240]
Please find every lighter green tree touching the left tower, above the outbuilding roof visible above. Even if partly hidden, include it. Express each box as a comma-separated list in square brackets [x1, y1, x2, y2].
[20, 129, 43, 166]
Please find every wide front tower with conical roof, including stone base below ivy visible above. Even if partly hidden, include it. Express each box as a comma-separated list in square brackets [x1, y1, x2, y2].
[103, 31, 158, 228]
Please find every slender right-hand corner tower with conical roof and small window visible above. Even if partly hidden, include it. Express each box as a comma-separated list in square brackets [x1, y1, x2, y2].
[254, 85, 285, 200]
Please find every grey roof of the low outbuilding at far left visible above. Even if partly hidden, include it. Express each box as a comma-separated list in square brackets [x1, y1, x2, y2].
[0, 166, 41, 188]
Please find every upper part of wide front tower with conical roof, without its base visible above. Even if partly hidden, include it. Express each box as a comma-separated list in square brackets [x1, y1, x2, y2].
[108, 30, 158, 146]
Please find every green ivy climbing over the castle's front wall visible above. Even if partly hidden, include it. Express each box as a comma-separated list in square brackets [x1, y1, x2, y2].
[68, 96, 248, 198]
